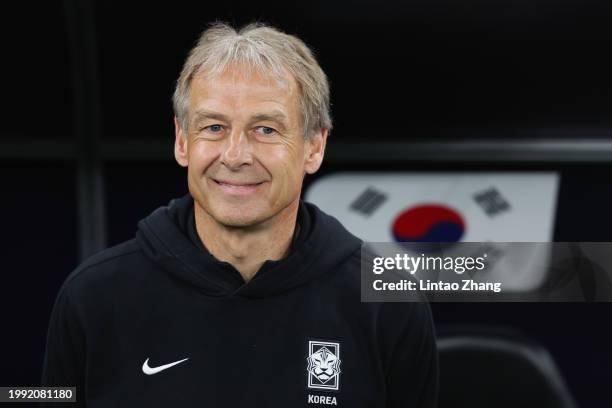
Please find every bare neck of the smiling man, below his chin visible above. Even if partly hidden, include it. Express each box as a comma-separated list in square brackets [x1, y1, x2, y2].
[194, 199, 299, 282]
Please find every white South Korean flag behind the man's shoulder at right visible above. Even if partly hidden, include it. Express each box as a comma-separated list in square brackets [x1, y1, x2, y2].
[305, 172, 559, 291]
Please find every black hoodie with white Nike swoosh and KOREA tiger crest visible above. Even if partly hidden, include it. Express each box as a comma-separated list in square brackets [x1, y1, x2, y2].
[42, 195, 437, 408]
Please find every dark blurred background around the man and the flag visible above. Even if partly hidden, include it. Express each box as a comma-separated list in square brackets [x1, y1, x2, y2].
[0, 0, 612, 407]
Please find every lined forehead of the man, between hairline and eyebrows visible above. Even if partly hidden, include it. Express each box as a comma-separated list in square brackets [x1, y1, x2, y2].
[189, 66, 299, 113]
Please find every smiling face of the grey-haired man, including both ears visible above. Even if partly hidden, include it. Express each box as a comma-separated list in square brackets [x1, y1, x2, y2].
[175, 68, 327, 227]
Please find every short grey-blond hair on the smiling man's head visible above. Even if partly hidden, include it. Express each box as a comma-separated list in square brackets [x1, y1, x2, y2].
[172, 23, 332, 137]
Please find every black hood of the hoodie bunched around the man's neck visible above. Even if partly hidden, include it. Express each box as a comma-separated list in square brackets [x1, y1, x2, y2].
[136, 194, 361, 298]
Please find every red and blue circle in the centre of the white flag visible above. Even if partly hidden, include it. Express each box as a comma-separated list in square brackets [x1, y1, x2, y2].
[392, 204, 465, 242]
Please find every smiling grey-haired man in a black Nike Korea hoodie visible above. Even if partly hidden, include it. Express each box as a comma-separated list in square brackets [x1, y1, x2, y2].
[43, 24, 437, 408]
